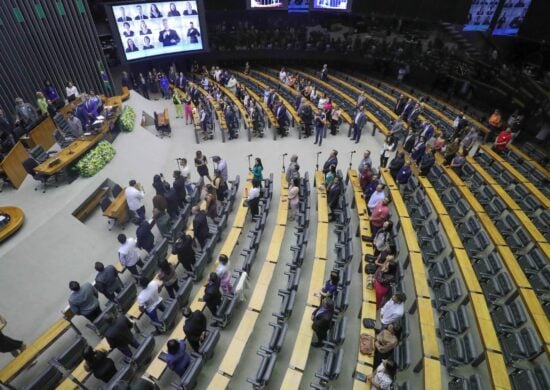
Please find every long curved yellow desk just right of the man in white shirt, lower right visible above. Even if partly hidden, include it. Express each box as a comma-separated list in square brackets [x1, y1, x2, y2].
[381, 169, 446, 388]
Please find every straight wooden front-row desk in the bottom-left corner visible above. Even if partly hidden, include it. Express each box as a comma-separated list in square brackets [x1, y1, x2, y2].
[0, 319, 71, 384]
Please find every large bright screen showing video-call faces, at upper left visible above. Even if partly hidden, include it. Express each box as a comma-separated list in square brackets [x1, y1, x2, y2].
[112, 1, 204, 61]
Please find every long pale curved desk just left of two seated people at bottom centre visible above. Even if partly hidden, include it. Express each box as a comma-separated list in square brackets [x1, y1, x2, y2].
[281, 171, 328, 389]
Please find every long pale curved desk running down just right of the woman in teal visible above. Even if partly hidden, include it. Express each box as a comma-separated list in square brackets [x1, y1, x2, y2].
[209, 174, 288, 389]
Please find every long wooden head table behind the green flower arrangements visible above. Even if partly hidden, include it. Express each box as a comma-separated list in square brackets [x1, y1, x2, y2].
[34, 113, 119, 176]
